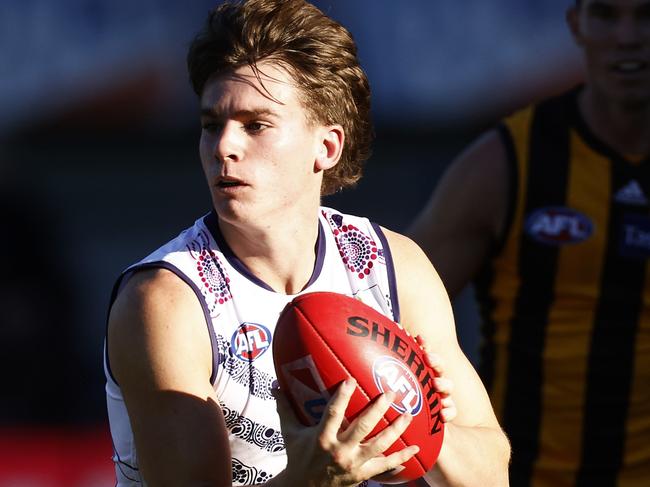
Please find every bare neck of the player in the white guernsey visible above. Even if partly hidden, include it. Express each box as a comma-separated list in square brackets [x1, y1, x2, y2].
[219, 211, 319, 294]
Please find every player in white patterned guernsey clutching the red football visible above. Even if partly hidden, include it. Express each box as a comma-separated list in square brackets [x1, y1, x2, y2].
[106, 0, 509, 487]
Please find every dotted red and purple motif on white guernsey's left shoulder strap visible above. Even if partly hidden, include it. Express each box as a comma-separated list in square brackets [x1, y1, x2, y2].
[187, 234, 232, 311]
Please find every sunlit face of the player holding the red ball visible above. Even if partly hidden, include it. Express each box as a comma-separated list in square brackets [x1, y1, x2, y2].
[200, 62, 324, 226]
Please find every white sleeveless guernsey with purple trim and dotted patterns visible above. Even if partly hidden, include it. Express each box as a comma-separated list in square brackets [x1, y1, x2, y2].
[104, 207, 399, 487]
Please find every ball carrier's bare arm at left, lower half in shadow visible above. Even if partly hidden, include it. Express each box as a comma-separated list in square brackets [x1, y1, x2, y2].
[108, 270, 231, 486]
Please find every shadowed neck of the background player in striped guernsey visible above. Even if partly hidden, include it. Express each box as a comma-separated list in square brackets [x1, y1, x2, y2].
[578, 86, 650, 156]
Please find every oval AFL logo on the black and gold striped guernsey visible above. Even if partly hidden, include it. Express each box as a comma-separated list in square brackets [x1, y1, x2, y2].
[524, 206, 594, 245]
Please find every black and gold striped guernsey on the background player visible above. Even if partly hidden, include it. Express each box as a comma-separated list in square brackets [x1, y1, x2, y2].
[476, 90, 650, 487]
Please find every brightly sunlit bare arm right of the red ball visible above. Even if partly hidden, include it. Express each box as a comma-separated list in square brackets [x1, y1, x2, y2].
[386, 231, 510, 486]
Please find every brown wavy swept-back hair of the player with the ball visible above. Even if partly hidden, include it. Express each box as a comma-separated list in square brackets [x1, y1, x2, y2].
[187, 0, 374, 195]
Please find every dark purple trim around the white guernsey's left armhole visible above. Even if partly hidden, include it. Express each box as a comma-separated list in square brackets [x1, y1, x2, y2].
[104, 260, 219, 386]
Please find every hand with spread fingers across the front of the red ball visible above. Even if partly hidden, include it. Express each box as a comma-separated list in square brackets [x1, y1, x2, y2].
[274, 379, 419, 487]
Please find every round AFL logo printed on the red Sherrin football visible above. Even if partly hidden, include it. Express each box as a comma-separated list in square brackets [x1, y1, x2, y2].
[372, 356, 422, 416]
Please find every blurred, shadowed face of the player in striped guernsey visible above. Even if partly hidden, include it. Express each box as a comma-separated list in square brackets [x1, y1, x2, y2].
[568, 0, 650, 105]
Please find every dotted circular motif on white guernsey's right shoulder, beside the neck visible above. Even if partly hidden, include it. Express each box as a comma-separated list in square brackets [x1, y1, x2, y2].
[330, 214, 380, 279]
